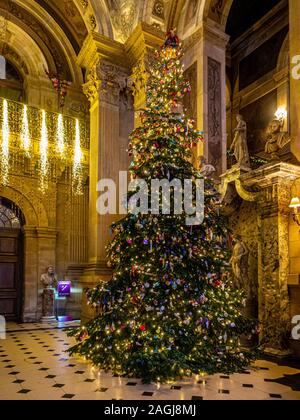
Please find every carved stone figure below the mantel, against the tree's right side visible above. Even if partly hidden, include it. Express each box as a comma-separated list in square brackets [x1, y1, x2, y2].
[230, 235, 250, 293]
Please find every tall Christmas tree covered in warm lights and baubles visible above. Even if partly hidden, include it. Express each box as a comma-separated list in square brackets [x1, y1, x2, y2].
[69, 32, 255, 383]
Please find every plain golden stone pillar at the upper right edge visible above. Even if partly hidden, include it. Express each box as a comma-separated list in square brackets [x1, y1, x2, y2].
[289, 0, 300, 160]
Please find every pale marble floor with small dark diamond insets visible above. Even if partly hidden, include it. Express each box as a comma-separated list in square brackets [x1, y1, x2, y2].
[0, 323, 300, 401]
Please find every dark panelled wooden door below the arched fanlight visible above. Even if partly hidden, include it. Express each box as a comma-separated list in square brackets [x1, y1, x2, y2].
[0, 229, 22, 321]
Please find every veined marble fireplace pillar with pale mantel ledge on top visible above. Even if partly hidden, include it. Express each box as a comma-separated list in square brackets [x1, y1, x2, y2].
[244, 163, 300, 356]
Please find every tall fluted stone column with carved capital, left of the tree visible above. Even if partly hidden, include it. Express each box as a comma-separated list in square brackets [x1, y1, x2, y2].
[78, 34, 133, 320]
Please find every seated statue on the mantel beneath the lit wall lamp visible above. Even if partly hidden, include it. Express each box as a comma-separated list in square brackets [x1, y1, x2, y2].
[265, 118, 291, 160]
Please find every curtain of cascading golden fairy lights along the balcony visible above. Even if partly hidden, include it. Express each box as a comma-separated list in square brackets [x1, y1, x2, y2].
[0, 99, 86, 195]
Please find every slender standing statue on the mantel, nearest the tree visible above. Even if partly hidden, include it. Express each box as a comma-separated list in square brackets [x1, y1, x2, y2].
[230, 114, 250, 170]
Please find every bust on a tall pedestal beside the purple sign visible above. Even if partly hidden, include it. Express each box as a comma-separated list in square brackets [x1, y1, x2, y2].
[41, 265, 58, 322]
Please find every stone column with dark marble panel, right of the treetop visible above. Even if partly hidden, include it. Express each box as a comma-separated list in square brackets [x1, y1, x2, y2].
[184, 22, 229, 175]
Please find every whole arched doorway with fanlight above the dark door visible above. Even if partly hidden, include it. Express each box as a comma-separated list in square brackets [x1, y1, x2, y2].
[0, 197, 25, 321]
